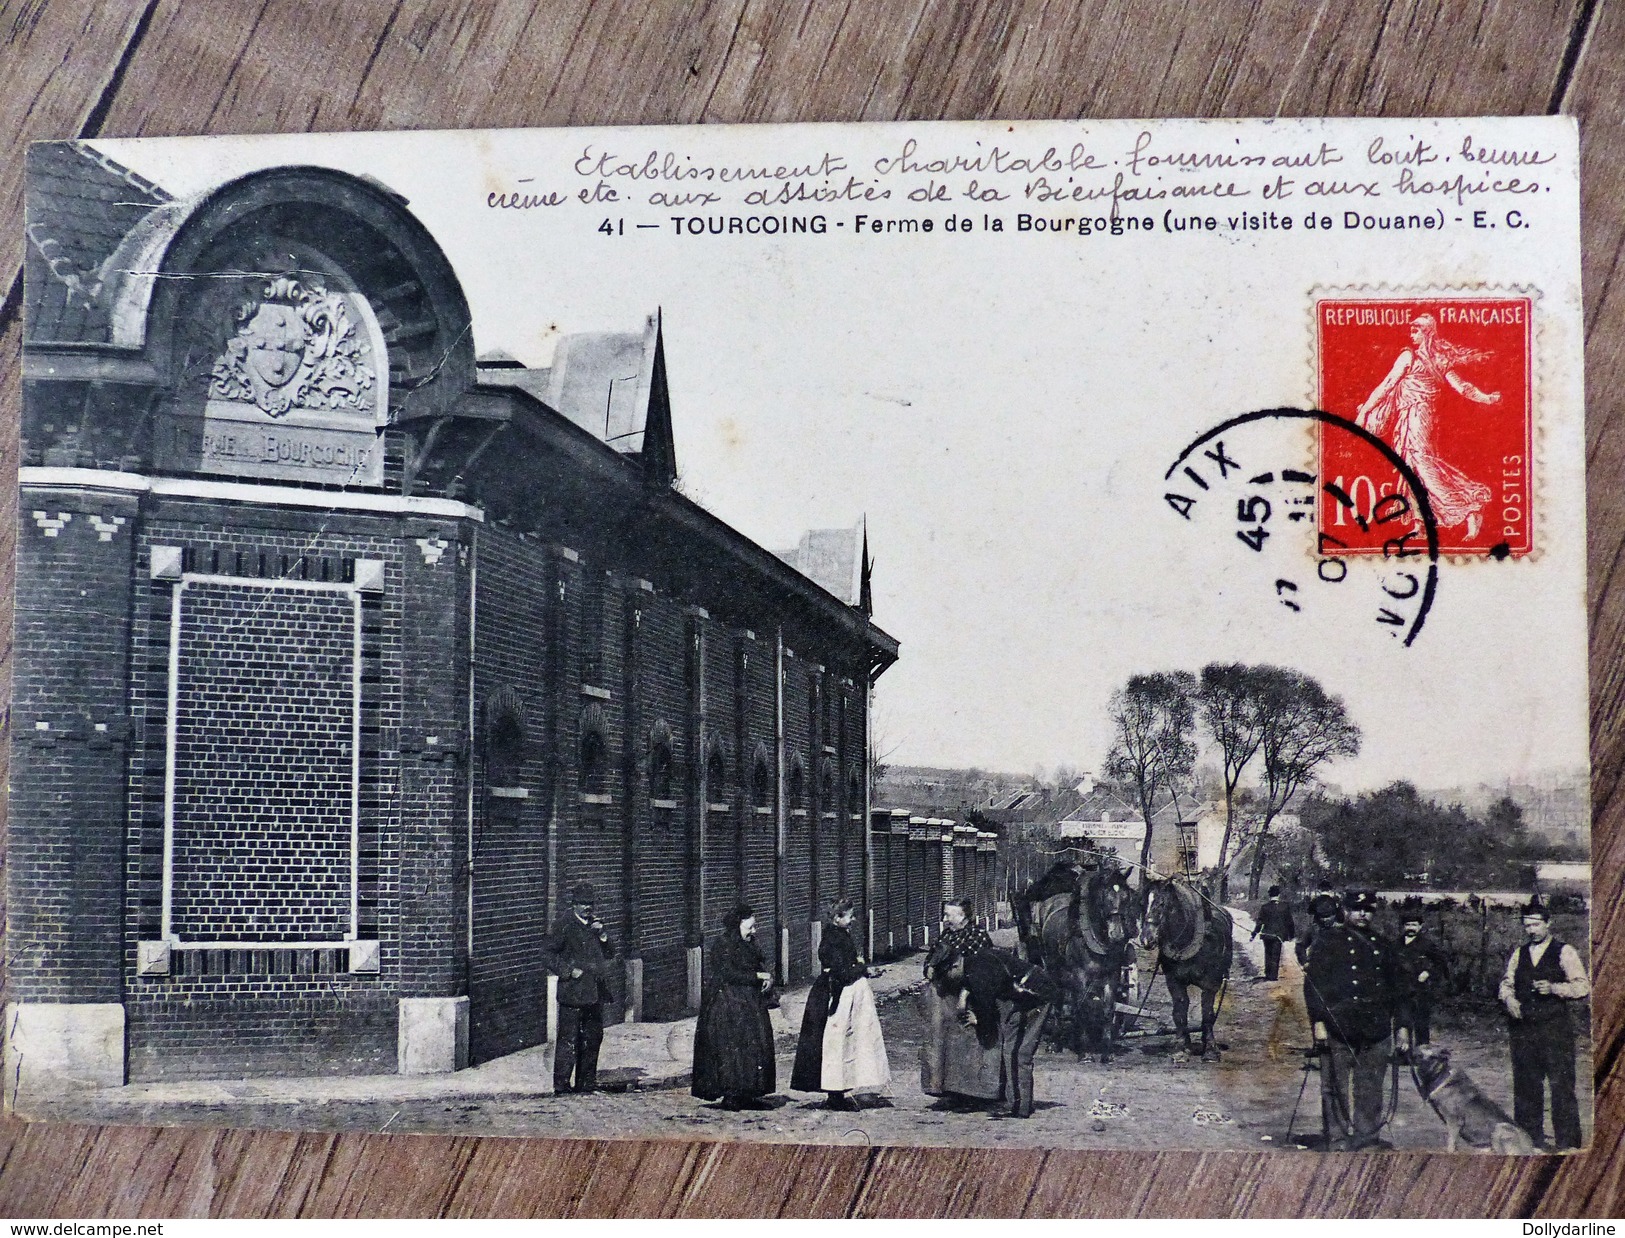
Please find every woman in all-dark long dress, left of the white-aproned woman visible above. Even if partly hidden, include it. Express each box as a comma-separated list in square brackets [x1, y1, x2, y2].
[689, 903, 775, 1110]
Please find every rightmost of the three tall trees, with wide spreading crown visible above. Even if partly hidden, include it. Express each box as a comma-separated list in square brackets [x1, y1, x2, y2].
[1246, 666, 1360, 898]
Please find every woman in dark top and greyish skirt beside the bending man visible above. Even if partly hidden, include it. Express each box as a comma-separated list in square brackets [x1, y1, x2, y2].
[920, 900, 1004, 1108]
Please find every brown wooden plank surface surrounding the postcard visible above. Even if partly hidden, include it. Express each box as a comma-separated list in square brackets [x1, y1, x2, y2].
[0, 0, 1625, 1217]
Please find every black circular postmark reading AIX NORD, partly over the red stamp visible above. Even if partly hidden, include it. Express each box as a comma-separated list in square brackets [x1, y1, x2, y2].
[1164, 408, 1440, 645]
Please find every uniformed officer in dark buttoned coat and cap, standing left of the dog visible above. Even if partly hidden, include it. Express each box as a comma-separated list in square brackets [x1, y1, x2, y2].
[1303, 889, 1411, 1152]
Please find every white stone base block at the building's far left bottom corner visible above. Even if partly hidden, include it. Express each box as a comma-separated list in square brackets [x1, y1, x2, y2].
[5, 1002, 124, 1105]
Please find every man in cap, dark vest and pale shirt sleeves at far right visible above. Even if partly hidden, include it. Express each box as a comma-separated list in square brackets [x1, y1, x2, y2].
[1500, 897, 1591, 1150]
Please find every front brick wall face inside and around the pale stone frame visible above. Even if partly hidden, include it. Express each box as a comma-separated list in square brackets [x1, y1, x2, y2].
[122, 499, 416, 1080]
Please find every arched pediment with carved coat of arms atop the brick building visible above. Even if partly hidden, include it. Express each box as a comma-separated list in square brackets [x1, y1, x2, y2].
[107, 167, 475, 486]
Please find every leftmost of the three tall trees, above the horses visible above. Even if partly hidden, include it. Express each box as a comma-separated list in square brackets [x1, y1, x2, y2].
[1105, 671, 1196, 869]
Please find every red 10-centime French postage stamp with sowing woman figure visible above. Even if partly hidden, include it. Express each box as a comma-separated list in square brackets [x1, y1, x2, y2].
[1315, 296, 1534, 559]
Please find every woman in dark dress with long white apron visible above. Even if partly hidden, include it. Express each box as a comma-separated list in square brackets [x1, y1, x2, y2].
[790, 898, 892, 1113]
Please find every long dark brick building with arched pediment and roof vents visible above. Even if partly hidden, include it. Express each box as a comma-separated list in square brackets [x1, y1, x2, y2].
[7, 143, 897, 1082]
